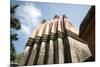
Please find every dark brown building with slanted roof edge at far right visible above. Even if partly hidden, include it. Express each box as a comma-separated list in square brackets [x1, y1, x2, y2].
[79, 6, 95, 61]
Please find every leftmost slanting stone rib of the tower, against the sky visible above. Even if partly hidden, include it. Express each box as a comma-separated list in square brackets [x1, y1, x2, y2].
[20, 24, 41, 65]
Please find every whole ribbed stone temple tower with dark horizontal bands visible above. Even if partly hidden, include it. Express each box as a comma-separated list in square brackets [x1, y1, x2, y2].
[20, 15, 91, 65]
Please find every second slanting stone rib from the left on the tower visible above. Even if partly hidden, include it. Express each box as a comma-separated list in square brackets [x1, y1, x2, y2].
[28, 23, 46, 65]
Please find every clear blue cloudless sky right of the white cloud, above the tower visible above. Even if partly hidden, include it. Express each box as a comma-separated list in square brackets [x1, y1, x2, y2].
[35, 3, 90, 28]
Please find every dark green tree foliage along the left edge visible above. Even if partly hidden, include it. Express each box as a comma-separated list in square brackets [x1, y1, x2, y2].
[10, 5, 21, 62]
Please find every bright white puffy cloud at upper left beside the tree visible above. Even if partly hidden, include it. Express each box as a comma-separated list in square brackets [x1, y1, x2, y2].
[15, 3, 41, 34]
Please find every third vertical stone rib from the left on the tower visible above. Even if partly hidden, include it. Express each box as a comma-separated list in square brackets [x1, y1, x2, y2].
[37, 23, 50, 64]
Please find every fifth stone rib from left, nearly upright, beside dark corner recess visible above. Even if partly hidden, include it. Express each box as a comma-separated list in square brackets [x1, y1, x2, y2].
[57, 17, 64, 64]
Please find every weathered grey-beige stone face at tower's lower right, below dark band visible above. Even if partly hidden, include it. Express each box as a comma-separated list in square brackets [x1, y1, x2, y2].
[68, 37, 91, 62]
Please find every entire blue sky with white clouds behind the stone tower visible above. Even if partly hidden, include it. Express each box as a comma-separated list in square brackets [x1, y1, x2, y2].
[11, 0, 91, 53]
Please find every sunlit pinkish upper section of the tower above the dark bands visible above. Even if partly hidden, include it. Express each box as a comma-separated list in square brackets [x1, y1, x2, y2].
[32, 15, 78, 37]
